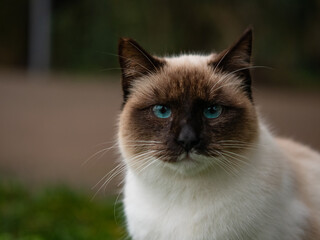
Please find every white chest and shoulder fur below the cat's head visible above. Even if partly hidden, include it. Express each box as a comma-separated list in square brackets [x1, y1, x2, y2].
[124, 126, 307, 240]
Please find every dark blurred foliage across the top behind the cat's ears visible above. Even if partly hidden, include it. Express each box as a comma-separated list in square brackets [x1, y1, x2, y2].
[0, 0, 320, 84]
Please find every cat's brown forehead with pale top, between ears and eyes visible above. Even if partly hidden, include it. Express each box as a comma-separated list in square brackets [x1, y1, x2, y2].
[129, 55, 244, 107]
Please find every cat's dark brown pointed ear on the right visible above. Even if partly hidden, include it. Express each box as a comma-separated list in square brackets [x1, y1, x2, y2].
[209, 27, 252, 100]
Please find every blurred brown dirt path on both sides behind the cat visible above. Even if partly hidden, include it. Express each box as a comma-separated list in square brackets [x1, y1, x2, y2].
[0, 73, 320, 191]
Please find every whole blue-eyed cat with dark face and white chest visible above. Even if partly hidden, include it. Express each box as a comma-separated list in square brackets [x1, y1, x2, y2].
[118, 28, 320, 240]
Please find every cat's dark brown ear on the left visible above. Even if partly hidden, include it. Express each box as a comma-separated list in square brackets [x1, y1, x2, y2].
[118, 38, 165, 102]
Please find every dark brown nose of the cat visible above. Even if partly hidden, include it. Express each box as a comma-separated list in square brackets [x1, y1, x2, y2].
[177, 124, 199, 151]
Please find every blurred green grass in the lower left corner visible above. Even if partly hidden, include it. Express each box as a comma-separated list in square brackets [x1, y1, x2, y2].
[0, 182, 126, 240]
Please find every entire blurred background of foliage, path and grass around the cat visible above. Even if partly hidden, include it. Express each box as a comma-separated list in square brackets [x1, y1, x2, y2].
[0, 0, 320, 240]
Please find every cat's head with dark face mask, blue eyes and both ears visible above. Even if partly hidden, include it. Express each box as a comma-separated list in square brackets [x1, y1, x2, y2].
[119, 29, 258, 173]
